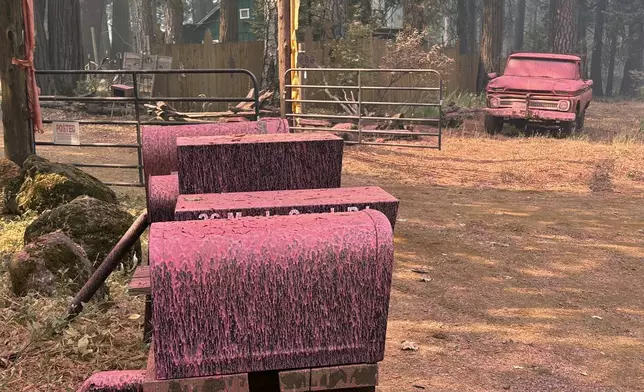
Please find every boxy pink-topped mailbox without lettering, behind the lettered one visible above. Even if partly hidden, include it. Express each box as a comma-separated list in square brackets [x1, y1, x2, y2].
[177, 132, 344, 195]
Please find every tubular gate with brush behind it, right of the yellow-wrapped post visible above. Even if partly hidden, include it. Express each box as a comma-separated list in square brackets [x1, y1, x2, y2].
[285, 68, 443, 150]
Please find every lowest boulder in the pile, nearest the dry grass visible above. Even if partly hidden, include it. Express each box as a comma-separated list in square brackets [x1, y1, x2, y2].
[8, 231, 105, 296]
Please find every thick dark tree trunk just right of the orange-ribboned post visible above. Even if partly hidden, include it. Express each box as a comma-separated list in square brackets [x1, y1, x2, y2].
[47, 0, 83, 95]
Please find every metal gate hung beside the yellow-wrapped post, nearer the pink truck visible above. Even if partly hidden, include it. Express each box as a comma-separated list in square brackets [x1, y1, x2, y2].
[285, 68, 443, 149]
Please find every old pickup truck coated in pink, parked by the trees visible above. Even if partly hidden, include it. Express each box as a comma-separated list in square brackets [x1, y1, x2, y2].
[485, 53, 593, 135]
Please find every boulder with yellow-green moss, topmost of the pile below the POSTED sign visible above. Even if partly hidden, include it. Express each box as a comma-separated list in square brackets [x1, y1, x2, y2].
[3, 155, 117, 214]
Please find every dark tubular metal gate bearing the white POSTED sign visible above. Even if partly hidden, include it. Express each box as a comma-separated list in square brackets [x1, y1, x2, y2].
[34, 69, 260, 186]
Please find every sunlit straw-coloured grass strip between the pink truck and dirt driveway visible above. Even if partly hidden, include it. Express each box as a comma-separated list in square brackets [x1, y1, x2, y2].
[346, 137, 644, 192]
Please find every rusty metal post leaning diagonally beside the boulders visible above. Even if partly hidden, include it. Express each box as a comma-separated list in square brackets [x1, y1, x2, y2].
[67, 212, 149, 320]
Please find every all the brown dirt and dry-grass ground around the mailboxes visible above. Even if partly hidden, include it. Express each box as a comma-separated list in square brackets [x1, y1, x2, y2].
[0, 102, 644, 392]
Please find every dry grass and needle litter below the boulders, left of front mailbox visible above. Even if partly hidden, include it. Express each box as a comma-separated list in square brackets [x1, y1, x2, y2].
[0, 258, 146, 391]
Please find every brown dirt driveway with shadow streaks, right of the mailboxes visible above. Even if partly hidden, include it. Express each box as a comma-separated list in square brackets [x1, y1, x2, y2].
[368, 179, 644, 392]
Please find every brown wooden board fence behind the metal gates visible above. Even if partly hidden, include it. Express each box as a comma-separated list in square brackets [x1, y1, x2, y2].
[153, 39, 479, 111]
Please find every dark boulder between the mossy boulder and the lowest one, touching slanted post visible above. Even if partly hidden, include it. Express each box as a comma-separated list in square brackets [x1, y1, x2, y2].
[25, 196, 141, 267]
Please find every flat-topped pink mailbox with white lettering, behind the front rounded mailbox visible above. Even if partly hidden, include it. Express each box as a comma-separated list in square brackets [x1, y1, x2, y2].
[174, 187, 398, 227]
